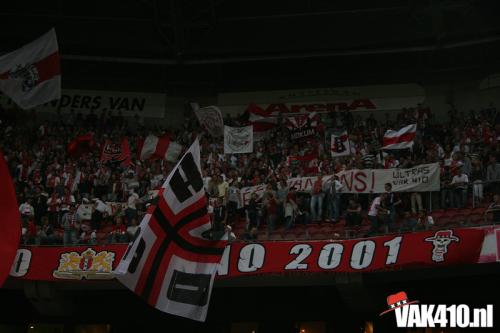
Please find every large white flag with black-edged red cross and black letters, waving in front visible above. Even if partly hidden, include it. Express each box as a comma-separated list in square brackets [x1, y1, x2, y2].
[115, 140, 225, 321]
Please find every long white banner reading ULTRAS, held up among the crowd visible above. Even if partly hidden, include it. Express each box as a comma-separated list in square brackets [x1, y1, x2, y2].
[241, 163, 440, 205]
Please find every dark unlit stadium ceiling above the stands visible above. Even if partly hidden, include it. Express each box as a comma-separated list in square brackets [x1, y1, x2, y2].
[0, 0, 500, 94]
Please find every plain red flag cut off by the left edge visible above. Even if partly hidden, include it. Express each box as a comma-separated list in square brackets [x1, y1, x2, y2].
[0, 152, 21, 287]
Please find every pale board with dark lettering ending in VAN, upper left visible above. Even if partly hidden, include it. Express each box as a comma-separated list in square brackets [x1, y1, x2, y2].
[0, 89, 165, 118]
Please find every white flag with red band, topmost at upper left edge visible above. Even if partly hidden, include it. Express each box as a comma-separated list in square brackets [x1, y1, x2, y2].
[0, 29, 61, 109]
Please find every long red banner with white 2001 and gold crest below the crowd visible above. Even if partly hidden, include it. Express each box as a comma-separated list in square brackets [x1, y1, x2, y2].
[10, 228, 485, 281]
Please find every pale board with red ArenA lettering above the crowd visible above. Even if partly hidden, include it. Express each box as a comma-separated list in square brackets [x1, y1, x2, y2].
[218, 84, 425, 116]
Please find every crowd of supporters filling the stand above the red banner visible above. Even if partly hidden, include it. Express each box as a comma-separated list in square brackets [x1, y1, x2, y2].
[0, 100, 500, 244]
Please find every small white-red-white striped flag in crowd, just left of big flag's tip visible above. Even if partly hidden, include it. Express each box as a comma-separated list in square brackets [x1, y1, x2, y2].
[139, 135, 182, 162]
